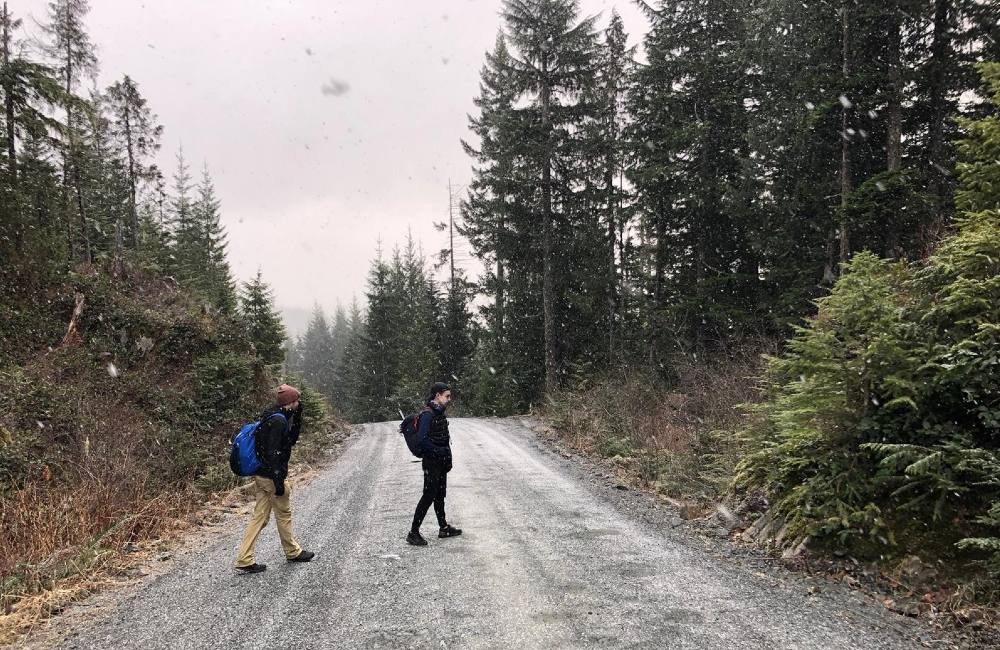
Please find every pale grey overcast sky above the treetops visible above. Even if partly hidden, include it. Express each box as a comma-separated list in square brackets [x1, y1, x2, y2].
[17, 0, 648, 330]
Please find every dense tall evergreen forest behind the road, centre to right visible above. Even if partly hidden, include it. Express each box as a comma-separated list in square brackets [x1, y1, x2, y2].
[289, 0, 1000, 420]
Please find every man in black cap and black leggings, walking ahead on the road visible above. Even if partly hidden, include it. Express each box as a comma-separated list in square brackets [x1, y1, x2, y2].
[406, 382, 462, 546]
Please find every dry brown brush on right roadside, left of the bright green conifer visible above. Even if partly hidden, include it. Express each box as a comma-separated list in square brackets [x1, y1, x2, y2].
[542, 342, 773, 498]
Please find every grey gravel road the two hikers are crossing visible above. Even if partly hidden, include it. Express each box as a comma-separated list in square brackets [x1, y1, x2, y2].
[56, 419, 940, 650]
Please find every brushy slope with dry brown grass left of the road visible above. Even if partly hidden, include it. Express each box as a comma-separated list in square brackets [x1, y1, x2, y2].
[0, 264, 340, 629]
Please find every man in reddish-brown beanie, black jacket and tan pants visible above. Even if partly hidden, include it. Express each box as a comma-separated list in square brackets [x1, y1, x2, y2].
[236, 384, 315, 573]
